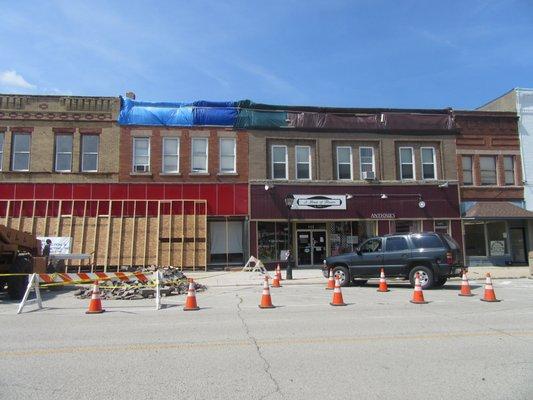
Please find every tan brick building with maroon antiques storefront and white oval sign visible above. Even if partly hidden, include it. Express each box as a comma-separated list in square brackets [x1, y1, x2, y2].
[246, 105, 462, 266]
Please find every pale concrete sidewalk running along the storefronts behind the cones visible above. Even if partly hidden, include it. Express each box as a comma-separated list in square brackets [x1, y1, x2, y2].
[184, 267, 533, 287]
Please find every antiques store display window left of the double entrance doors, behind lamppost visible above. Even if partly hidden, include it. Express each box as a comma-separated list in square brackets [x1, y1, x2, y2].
[257, 222, 289, 262]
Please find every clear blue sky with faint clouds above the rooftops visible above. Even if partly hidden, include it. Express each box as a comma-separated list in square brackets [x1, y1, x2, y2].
[0, 0, 533, 109]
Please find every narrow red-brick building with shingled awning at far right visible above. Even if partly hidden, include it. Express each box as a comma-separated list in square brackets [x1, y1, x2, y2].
[455, 111, 533, 265]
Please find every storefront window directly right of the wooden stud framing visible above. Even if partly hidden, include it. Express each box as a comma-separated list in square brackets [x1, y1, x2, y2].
[209, 221, 244, 264]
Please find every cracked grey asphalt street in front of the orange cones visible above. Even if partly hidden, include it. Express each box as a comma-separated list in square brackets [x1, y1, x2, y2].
[0, 279, 533, 400]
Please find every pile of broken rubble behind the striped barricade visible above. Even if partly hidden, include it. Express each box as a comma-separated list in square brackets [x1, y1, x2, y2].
[74, 267, 207, 300]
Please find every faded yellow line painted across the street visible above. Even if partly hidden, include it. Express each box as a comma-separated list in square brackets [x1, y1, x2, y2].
[0, 331, 533, 357]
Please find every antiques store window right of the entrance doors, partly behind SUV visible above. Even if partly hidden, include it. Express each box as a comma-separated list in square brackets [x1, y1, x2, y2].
[329, 221, 377, 256]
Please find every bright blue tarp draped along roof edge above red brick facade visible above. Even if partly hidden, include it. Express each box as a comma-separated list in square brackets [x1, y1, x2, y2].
[118, 97, 238, 126]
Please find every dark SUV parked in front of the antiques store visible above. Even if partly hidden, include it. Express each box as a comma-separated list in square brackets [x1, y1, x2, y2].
[323, 232, 464, 289]
